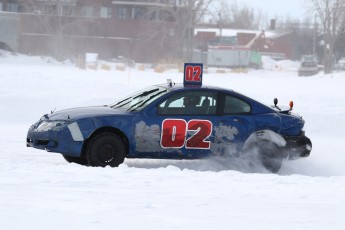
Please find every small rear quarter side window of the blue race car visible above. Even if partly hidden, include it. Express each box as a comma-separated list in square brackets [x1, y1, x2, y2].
[224, 95, 251, 114]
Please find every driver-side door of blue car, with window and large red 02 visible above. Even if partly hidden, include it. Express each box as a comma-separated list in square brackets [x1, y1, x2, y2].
[135, 89, 218, 158]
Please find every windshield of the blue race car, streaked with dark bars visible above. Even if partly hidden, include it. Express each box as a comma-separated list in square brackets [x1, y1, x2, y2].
[110, 86, 168, 111]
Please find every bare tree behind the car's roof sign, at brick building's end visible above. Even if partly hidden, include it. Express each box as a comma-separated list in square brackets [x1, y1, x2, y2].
[105, 0, 214, 61]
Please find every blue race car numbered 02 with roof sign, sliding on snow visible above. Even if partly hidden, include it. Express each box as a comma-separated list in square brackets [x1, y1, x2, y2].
[27, 64, 312, 172]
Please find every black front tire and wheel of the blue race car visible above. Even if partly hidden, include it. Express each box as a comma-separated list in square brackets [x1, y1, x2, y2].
[86, 133, 126, 167]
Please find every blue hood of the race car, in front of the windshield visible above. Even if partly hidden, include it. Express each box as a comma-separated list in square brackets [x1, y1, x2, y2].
[44, 106, 130, 120]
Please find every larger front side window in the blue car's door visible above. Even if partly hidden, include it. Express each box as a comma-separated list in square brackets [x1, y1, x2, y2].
[157, 90, 217, 115]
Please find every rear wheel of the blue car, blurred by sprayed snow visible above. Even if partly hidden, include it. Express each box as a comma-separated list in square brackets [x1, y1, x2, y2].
[257, 141, 283, 173]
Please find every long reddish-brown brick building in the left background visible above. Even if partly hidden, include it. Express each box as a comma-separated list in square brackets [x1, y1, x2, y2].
[0, 0, 185, 62]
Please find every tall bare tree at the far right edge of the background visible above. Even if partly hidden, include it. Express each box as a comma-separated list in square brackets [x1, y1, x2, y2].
[312, 0, 345, 74]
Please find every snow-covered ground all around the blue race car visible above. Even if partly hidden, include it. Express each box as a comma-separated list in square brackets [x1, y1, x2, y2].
[0, 54, 345, 230]
